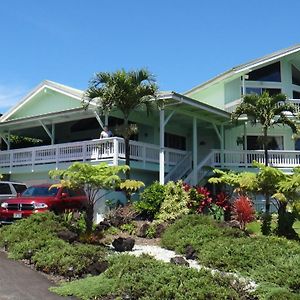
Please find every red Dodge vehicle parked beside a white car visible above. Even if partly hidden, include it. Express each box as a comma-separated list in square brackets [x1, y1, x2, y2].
[0, 184, 87, 224]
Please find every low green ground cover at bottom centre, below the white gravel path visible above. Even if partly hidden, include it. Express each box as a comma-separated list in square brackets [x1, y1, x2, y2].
[52, 255, 253, 300]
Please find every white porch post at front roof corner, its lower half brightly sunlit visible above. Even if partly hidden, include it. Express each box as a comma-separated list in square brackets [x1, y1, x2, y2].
[159, 108, 165, 185]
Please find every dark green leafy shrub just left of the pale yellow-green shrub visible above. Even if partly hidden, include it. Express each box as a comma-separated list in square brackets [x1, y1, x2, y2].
[134, 181, 165, 219]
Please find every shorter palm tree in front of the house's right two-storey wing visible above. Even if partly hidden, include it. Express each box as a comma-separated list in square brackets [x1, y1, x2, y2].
[231, 91, 297, 166]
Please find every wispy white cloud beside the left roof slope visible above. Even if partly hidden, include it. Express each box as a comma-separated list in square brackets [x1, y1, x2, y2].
[0, 84, 28, 113]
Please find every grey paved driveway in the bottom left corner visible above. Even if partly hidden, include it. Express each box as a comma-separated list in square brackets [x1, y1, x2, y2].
[0, 252, 74, 300]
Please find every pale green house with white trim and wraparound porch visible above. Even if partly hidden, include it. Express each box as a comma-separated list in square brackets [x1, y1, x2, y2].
[0, 45, 300, 213]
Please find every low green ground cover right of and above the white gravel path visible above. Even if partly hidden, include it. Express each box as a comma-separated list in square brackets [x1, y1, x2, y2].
[162, 215, 300, 299]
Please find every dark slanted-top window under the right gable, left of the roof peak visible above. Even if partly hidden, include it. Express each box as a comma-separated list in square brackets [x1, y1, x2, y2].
[246, 62, 281, 82]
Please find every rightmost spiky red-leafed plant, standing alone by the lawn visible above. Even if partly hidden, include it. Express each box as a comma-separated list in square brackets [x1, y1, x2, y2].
[232, 195, 255, 230]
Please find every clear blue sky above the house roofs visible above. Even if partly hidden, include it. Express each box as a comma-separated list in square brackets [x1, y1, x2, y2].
[0, 0, 300, 112]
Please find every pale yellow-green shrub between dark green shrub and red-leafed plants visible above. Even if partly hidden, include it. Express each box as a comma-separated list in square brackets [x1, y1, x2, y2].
[156, 180, 189, 221]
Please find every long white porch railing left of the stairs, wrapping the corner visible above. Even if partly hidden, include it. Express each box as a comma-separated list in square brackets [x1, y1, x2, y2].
[0, 137, 186, 170]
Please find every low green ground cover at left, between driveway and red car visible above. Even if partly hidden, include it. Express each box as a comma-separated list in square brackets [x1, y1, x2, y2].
[0, 212, 106, 277]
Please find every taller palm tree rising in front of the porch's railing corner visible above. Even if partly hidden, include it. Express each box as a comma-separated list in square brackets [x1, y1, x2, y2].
[83, 69, 158, 178]
